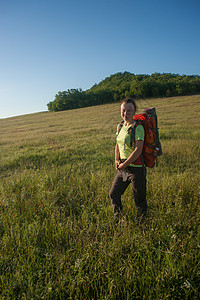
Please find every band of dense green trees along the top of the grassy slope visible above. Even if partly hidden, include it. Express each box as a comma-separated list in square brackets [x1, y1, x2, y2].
[47, 72, 200, 111]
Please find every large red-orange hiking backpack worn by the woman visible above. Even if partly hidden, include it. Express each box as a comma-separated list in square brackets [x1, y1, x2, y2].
[118, 107, 162, 168]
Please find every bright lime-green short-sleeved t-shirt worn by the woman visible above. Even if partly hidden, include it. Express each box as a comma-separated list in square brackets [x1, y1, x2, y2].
[117, 124, 144, 167]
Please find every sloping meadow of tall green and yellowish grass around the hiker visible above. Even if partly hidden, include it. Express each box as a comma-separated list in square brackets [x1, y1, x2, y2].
[0, 95, 200, 300]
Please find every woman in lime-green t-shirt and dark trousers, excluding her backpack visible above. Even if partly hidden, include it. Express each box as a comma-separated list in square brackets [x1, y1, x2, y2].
[110, 98, 147, 220]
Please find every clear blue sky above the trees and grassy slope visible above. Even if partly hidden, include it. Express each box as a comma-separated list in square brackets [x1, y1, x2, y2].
[0, 0, 200, 118]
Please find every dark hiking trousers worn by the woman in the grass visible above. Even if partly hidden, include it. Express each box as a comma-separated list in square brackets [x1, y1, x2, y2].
[110, 167, 147, 218]
